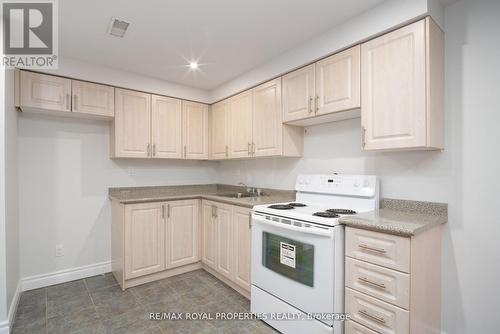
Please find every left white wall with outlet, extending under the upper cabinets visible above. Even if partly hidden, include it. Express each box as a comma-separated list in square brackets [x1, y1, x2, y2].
[18, 113, 214, 278]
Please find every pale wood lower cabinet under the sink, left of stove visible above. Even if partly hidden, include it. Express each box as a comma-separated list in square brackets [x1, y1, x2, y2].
[202, 200, 251, 291]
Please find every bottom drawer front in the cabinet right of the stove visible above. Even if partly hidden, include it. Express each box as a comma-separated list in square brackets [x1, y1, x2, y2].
[345, 288, 410, 334]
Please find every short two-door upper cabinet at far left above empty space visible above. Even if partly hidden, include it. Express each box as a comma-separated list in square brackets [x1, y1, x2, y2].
[16, 71, 115, 118]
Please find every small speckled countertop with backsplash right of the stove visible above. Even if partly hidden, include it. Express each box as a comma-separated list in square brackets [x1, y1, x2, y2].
[340, 199, 448, 237]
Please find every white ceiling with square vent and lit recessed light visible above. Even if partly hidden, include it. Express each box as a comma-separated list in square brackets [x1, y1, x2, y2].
[59, 0, 383, 90]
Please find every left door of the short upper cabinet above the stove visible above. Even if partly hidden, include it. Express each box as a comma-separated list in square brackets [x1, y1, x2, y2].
[283, 64, 316, 122]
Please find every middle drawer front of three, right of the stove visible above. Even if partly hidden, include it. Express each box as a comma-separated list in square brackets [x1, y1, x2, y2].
[345, 257, 410, 310]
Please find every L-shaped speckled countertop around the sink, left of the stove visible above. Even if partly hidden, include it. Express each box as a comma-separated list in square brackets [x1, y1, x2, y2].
[109, 184, 295, 208]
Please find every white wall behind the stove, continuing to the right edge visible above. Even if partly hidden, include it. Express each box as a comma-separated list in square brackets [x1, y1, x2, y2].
[218, 0, 500, 334]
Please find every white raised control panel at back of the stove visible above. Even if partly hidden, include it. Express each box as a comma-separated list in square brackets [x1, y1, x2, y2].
[295, 174, 378, 197]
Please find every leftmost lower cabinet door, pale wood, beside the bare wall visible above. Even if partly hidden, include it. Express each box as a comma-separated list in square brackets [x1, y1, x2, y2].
[125, 203, 165, 279]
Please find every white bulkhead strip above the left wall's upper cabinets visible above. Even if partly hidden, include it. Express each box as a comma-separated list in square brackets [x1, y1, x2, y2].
[39, 58, 210, 103]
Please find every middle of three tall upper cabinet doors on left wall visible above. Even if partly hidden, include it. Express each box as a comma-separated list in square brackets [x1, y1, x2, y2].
[151, 95, 182, 159]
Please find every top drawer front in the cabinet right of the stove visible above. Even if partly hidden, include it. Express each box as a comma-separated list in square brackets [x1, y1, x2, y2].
[346, 227, 410, 273]
